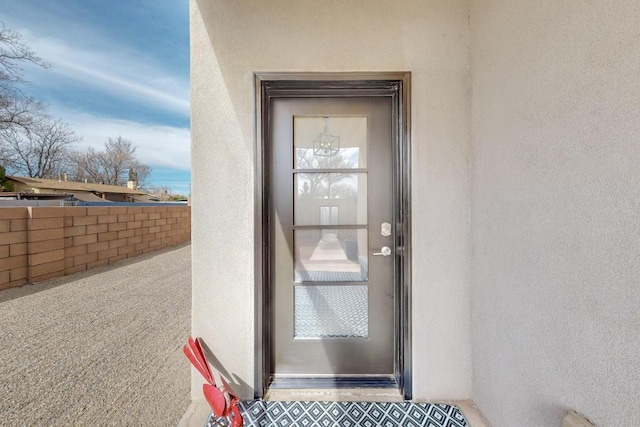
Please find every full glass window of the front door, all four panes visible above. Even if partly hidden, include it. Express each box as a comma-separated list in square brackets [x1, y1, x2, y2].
[293, 116, 369, 339]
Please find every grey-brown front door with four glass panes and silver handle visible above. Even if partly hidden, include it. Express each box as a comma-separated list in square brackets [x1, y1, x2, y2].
[269, 96, 398, 386]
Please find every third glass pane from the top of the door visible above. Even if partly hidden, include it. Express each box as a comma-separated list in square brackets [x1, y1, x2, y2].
[294, 228, 368, 282]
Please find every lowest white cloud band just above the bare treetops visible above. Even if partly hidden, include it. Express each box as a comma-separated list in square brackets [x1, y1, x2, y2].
[62, 111, 191, 170]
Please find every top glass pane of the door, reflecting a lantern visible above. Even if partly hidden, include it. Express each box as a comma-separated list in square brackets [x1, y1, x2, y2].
[293, 116, 367, 169]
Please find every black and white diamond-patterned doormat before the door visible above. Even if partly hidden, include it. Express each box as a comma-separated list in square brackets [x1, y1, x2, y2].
[206, 400, 469, 427]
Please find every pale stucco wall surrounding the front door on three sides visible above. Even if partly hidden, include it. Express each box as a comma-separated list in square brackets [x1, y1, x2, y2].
[191, 0, 471, 399]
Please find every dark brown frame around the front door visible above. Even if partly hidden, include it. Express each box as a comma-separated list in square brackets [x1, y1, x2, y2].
[254, 72, 413, 400]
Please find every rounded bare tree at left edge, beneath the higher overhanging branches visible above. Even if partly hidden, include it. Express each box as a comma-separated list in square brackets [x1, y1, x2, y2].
[3, 117, 80, 178]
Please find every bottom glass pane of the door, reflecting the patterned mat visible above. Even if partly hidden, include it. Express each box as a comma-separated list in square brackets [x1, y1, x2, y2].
[294, 285, 369, 338]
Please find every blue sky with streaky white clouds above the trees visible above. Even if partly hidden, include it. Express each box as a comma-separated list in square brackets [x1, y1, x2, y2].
[0, 0, 190, 194]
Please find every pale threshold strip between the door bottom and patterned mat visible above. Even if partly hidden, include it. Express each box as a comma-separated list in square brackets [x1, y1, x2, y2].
[263, 388, 404, 402]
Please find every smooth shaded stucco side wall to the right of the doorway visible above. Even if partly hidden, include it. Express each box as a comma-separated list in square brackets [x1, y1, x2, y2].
[471, 0, 640, 427]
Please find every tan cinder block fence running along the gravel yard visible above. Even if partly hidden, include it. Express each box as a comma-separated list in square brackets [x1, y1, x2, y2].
[0, 206, 191, 289]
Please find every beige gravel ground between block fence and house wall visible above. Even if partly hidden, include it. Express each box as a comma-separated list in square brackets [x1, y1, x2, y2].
[0, 245, 191, 427]
